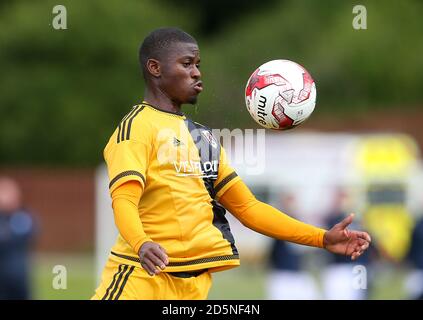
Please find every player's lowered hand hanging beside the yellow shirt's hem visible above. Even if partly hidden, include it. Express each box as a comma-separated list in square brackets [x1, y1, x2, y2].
[138, 241, 169, 276]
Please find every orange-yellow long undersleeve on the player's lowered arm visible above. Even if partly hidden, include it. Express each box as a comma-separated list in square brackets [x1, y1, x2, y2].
[112, 180, 151, 253]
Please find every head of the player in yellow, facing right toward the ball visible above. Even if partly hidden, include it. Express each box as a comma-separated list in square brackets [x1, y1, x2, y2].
[139, 28, 202, 105]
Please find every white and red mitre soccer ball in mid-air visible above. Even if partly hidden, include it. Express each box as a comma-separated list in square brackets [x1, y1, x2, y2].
[245, 60, 316, 130]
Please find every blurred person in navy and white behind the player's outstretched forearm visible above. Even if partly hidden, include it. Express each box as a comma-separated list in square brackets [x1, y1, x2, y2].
[266, 193, 319, 300]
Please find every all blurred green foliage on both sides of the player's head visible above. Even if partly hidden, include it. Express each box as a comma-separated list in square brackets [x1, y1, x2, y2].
[0, 0, 423, 166]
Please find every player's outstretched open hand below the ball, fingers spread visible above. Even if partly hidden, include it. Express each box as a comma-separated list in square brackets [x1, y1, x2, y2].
[323, 214, 372, 260]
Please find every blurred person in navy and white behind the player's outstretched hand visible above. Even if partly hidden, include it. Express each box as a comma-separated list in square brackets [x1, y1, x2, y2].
[321, 188, 374, 300]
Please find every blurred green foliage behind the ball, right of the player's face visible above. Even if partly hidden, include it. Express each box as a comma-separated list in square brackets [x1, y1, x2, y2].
[191, 0, 423, 128]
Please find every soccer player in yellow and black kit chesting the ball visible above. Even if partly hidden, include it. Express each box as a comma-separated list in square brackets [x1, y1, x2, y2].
[93, 28, 371, 300]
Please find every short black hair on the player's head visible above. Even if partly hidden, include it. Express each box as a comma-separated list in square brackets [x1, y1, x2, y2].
[138, 27, 197, 79]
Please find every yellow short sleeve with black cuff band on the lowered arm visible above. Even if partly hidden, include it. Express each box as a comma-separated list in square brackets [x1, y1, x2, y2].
[104, 116, 153, 193]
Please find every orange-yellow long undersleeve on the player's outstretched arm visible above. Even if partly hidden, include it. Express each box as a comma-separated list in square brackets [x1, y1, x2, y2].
[219, 180, 326, 248]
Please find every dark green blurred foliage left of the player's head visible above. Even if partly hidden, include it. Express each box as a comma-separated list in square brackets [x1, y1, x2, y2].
[0, 0, 194, 166]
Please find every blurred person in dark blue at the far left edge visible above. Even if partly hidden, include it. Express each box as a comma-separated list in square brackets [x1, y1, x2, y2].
[0, 177, 34, 300]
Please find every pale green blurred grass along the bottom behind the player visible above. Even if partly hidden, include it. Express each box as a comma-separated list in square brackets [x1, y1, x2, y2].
[32, 254, 406, 300]
